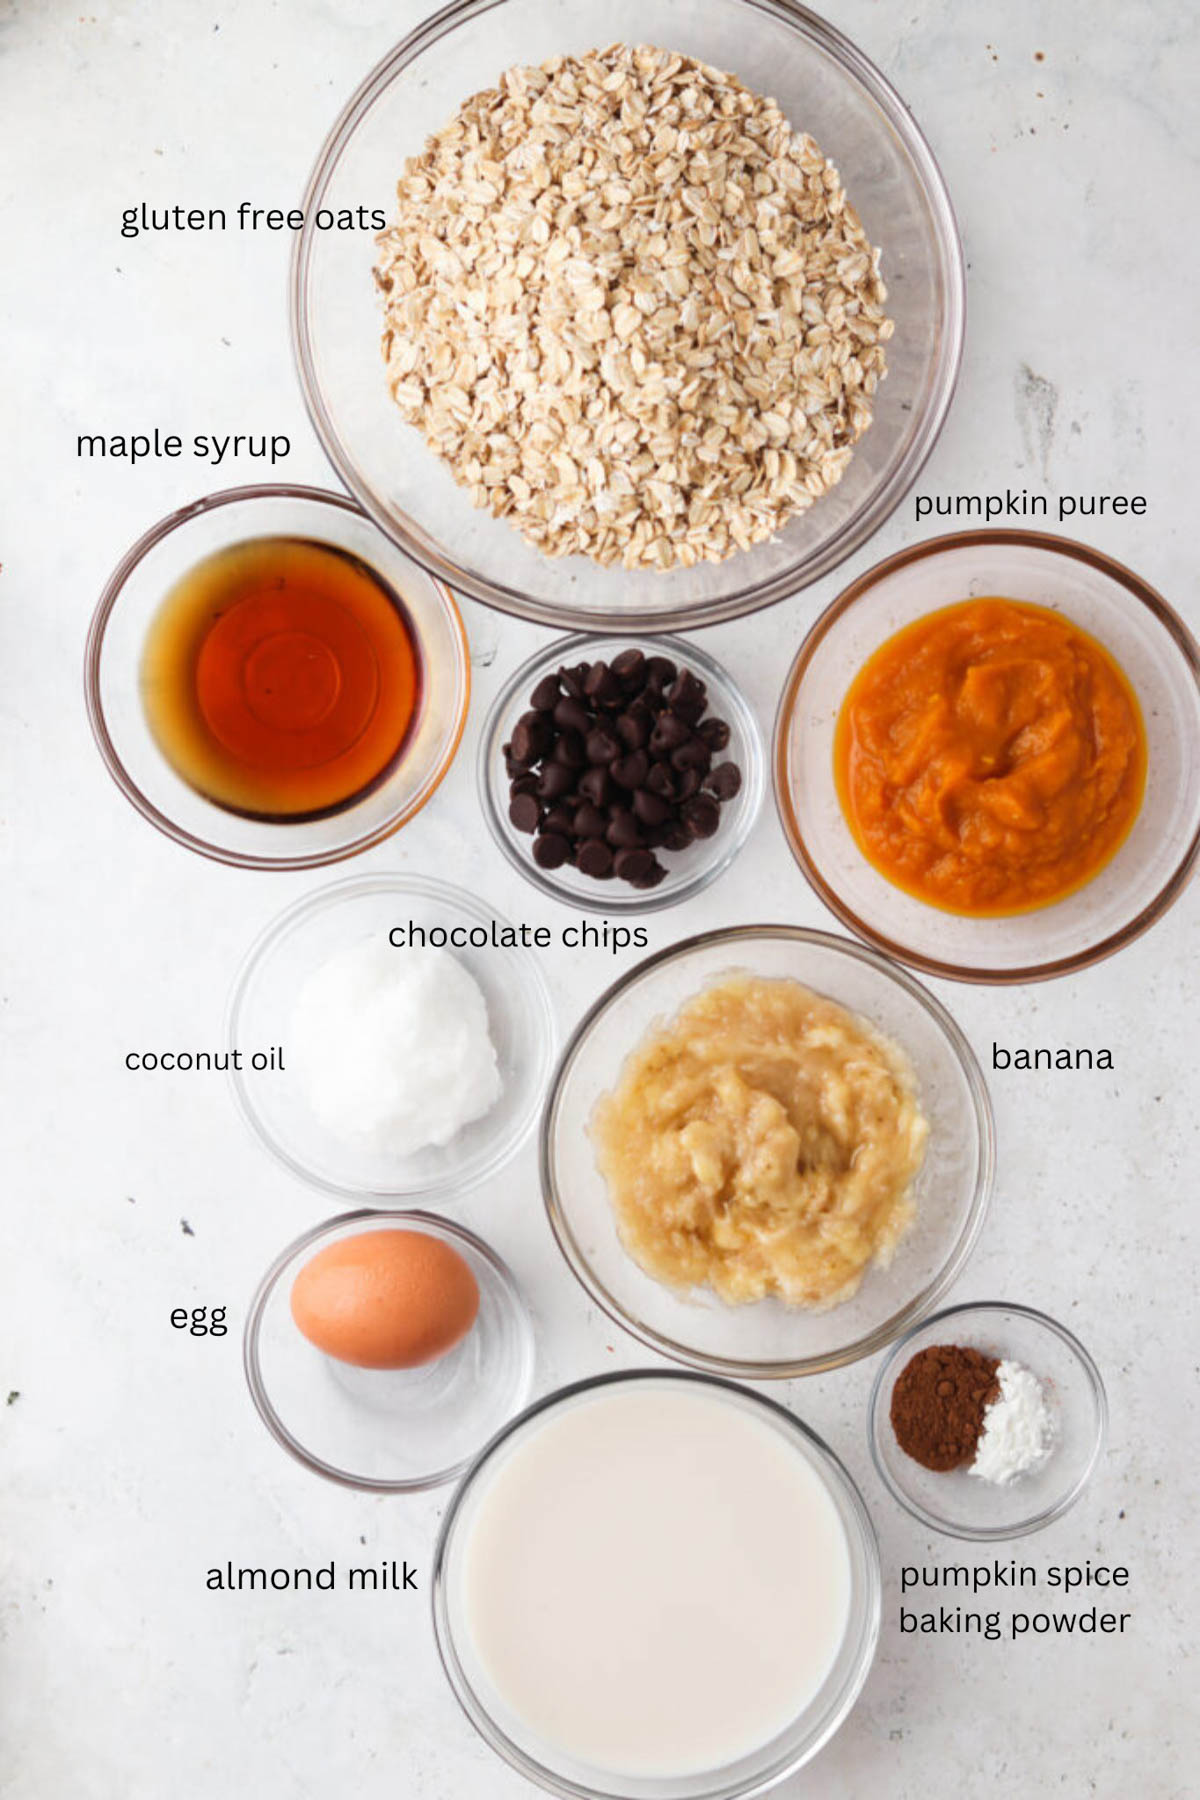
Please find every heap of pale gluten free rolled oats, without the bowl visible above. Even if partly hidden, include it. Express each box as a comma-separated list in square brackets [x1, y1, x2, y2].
[376, 43, 892, 569]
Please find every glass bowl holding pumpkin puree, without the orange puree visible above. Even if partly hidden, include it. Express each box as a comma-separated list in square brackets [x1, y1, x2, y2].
[774, 531, 1200, 983]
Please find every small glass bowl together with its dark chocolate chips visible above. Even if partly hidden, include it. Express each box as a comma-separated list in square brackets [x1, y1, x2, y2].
[479, 637, 765, 913]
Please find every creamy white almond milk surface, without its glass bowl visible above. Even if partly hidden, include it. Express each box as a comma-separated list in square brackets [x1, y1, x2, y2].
[461, 1381, 851, 1775]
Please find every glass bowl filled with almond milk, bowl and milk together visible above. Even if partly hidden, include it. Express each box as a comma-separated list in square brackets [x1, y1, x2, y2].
[434, 1370, 880, 1800]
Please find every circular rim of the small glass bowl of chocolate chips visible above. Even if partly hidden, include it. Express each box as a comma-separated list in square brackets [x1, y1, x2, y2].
[475, 632, 766, 914]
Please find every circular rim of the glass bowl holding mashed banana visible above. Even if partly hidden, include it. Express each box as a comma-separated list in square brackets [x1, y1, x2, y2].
[538, 925, 997, 1381]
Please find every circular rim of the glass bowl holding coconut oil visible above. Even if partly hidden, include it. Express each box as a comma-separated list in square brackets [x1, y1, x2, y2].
[221, 869, 558, 1211]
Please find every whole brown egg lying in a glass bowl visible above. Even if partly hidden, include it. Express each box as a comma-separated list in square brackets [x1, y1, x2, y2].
[291, 1231, 479, 1368]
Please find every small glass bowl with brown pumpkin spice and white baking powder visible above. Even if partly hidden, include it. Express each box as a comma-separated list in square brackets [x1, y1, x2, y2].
[869, 1300, 1108, 1543]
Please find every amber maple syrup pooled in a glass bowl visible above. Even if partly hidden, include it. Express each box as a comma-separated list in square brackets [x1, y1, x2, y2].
[142, 538, 421, 821]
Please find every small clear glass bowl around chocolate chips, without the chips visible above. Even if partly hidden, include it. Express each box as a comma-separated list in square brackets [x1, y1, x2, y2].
[479, 635, 766, 914]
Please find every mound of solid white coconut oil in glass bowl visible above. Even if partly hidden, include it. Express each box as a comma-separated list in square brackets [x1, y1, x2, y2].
[288, 938, 504, 1157]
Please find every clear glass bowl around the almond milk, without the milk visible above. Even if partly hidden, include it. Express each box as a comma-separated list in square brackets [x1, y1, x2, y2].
[434, 1370, 882, 1800]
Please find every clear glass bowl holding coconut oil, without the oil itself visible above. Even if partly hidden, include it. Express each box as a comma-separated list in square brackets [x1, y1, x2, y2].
[225, 875, 554, 1201]
